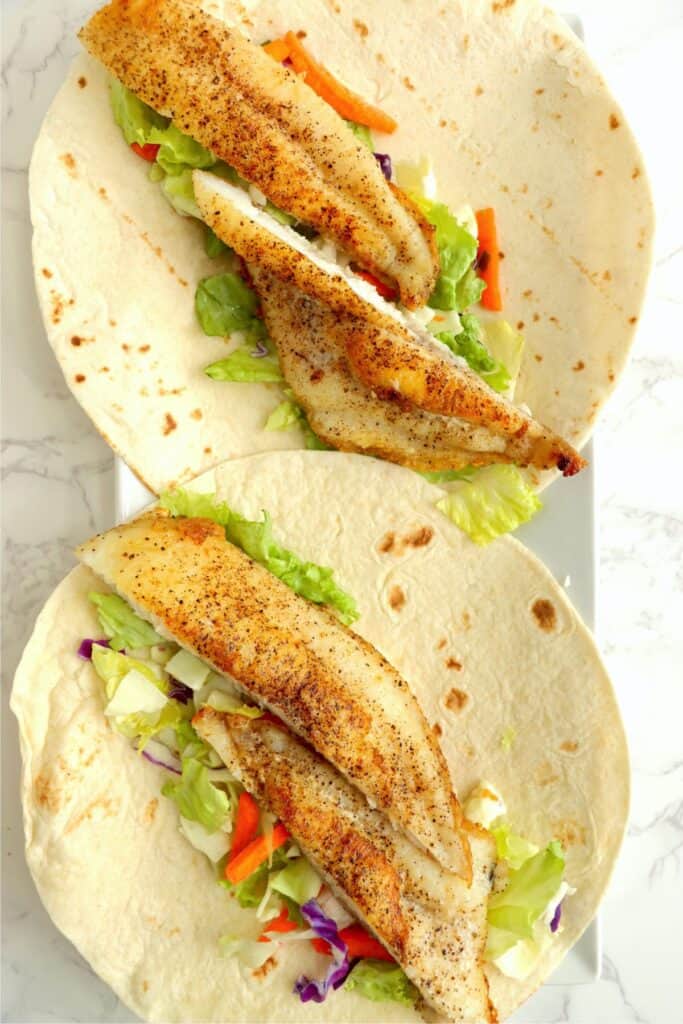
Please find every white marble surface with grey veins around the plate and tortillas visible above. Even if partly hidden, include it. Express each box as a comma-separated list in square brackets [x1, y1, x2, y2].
[1, 0, 683, 1024]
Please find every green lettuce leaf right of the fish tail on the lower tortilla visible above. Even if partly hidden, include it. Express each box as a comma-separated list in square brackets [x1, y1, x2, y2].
[486, 842, 564, 959]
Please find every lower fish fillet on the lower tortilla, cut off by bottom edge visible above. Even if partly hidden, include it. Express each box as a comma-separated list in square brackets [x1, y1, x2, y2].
[193, 708, 496, 1024]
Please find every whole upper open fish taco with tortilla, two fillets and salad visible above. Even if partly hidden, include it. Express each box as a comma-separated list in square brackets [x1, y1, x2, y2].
[31, 0, 652, 541]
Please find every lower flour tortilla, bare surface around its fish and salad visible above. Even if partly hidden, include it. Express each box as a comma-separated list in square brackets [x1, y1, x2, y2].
[11, 452, 629, 1024]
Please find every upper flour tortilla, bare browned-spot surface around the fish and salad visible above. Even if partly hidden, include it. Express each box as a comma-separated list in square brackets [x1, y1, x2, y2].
[30, 0, 652, 493]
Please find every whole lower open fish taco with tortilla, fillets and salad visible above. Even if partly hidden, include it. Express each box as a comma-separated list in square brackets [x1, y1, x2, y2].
[11, 452, 629, 1024]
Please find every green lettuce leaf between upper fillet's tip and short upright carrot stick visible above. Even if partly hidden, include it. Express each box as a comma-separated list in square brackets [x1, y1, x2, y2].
[413, 195, 483, 310]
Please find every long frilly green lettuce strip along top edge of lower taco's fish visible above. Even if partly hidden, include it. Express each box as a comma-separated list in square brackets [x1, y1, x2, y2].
[160, 489, 358, 625]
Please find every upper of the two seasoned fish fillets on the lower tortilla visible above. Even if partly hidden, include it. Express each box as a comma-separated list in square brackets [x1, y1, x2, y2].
[78, 510, 471, 881]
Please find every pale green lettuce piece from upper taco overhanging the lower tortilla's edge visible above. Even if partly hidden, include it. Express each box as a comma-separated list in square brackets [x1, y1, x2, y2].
[436, 465, 543, 545]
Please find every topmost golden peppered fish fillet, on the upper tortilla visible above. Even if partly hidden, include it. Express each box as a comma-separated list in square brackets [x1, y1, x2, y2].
[80, 0, 438, 307]
